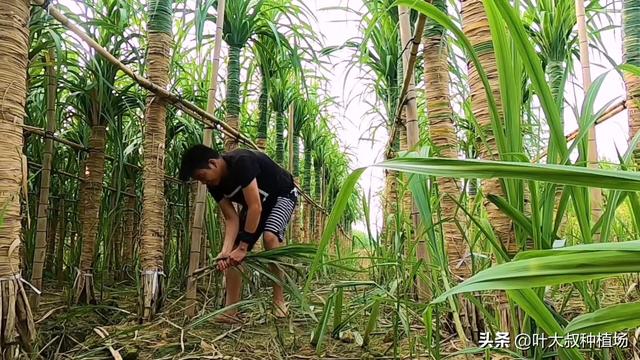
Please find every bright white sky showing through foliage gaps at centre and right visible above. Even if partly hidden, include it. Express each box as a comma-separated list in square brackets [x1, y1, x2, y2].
[308, 0, 628, 230]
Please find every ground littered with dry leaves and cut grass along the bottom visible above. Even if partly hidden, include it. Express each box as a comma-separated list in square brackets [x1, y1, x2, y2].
[34, 280, 638, 360]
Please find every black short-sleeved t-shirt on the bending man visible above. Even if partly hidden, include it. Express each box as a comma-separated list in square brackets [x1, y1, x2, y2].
[208, 149, 294, 207]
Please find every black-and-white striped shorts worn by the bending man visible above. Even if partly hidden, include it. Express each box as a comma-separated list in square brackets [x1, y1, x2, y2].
[240, 188, 298, 250]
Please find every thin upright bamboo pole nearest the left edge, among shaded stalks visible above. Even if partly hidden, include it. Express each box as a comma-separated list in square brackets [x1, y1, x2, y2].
[31, 49, 57, 310]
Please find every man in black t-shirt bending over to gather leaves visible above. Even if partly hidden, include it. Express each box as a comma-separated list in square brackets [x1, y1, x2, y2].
[180, 145, 298, 322]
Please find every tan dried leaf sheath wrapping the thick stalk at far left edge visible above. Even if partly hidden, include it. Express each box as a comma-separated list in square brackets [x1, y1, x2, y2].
[0, 0, 35, 359]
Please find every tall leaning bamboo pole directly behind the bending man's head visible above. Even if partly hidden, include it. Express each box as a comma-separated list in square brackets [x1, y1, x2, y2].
[186, 0, 226, 317]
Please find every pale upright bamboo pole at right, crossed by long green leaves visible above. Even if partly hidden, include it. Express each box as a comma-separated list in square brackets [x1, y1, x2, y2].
[576, 0, 602, 228]
